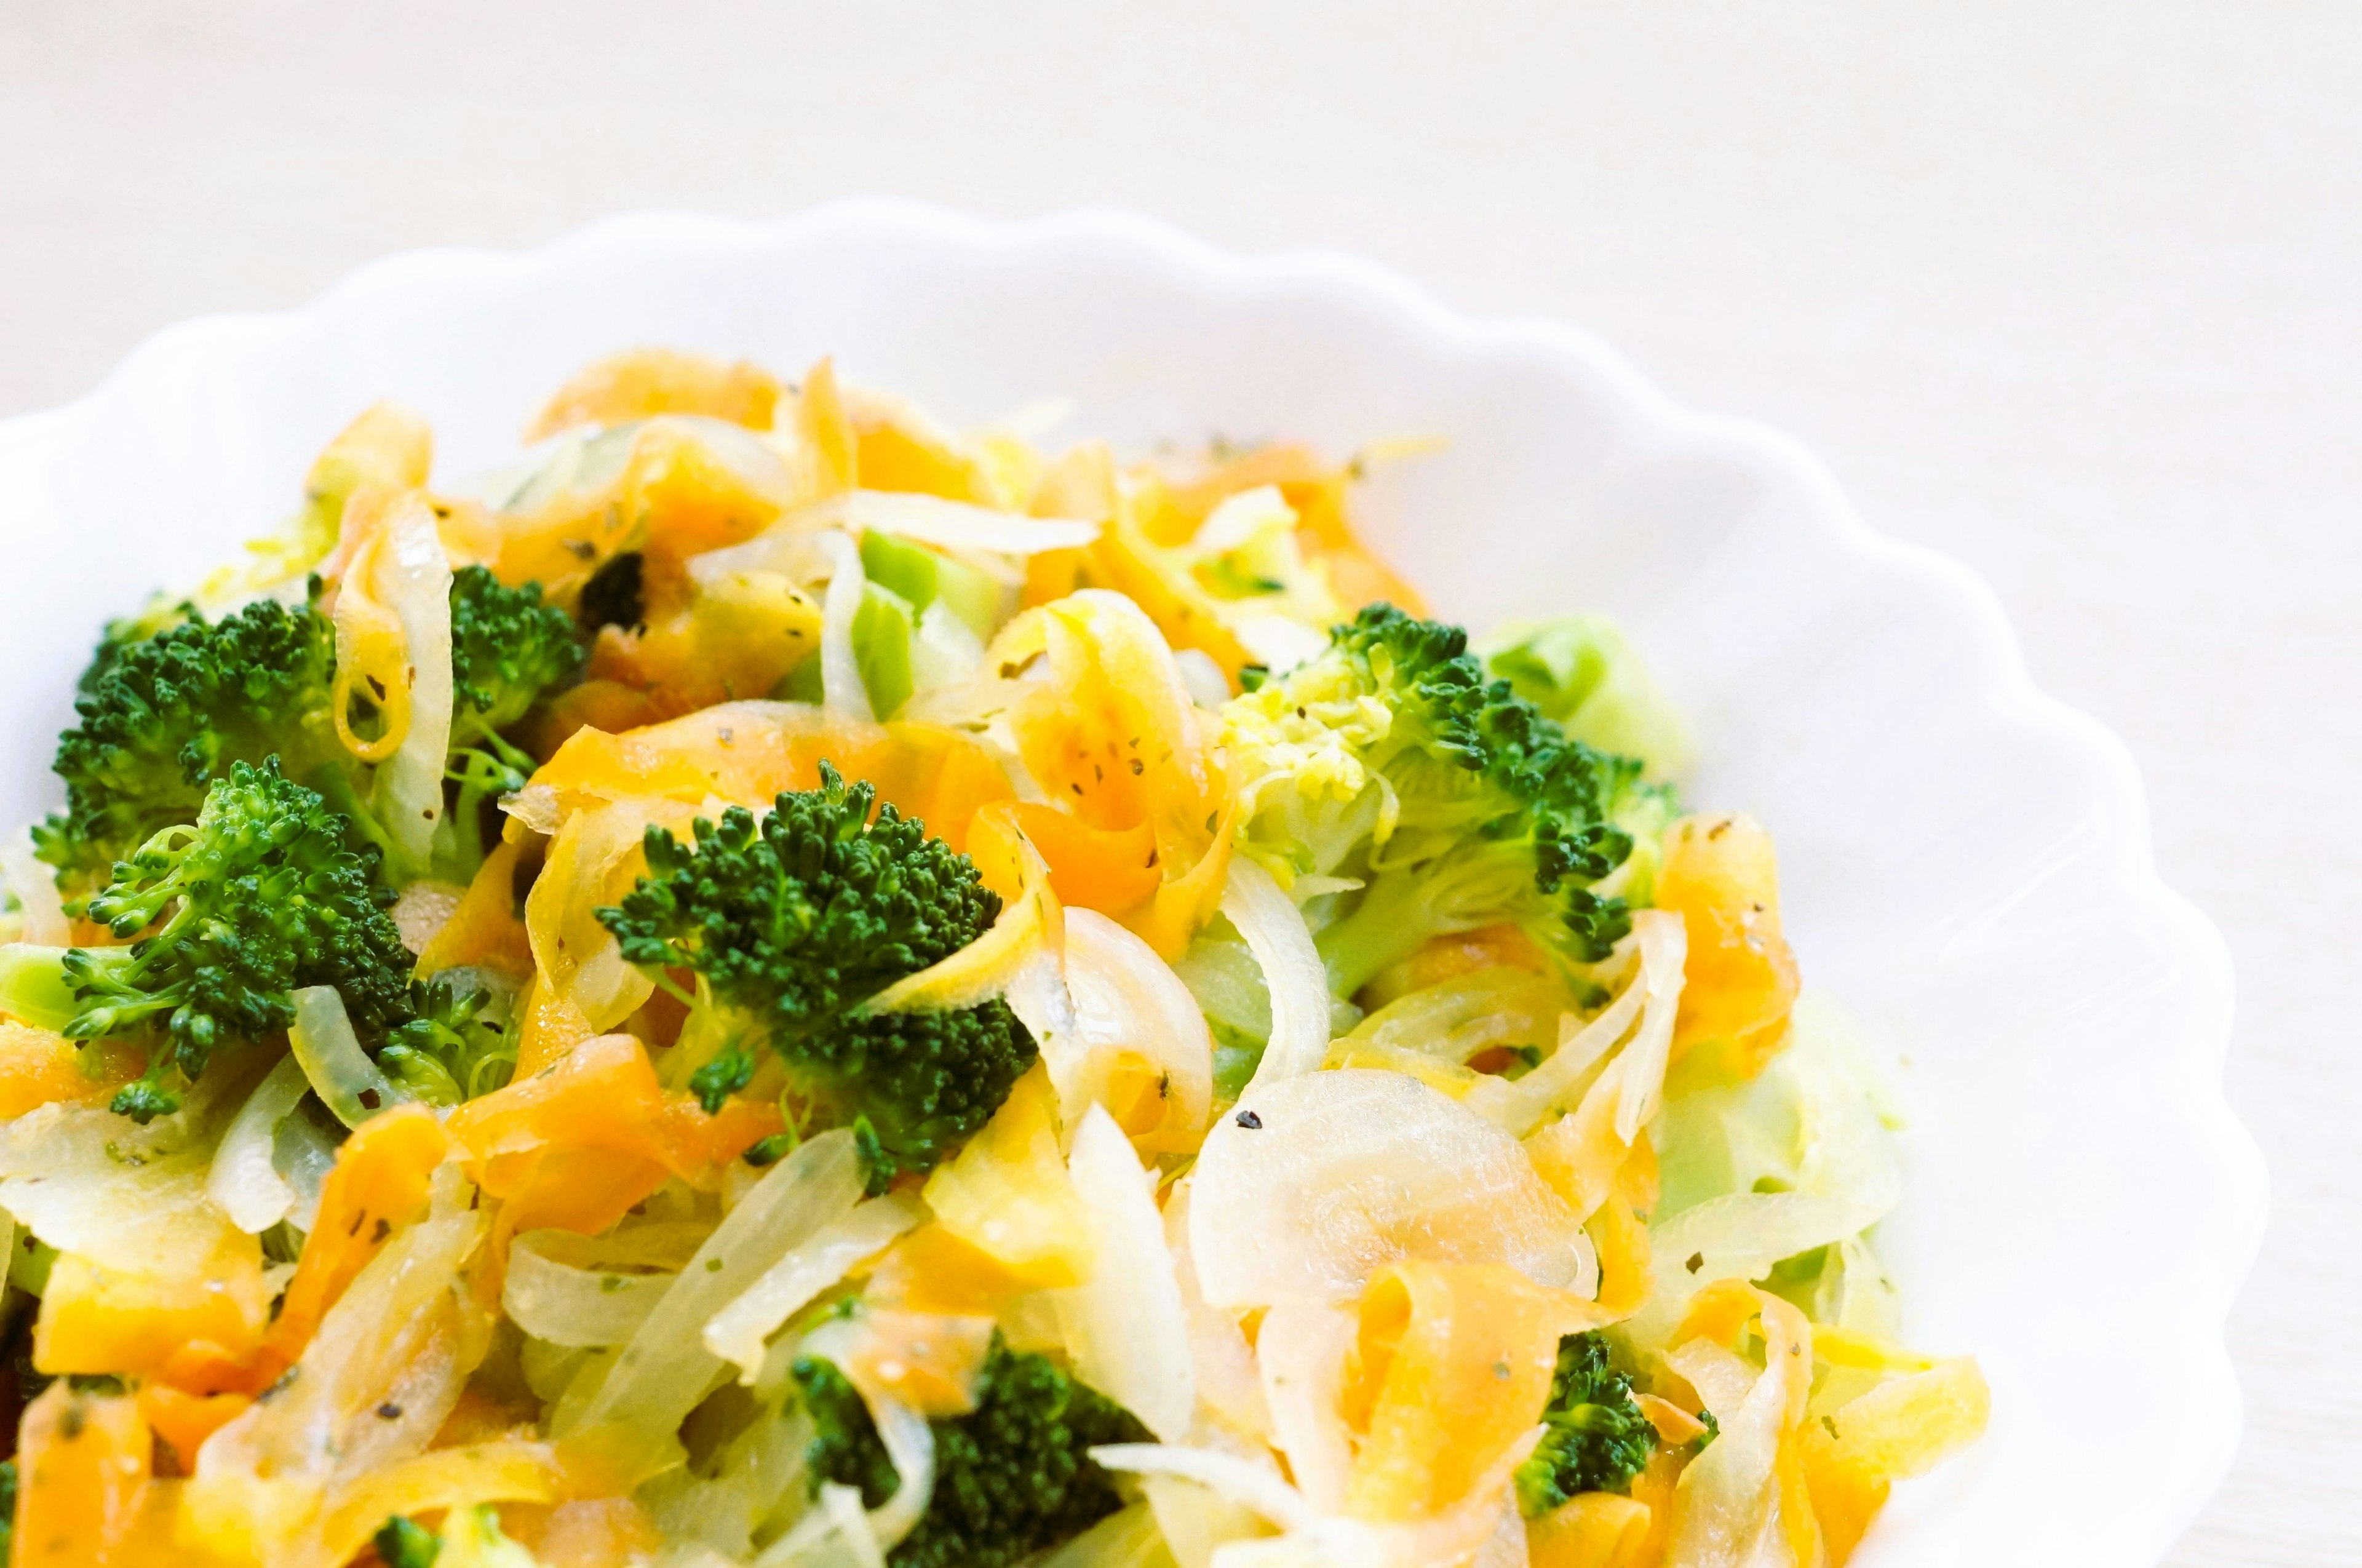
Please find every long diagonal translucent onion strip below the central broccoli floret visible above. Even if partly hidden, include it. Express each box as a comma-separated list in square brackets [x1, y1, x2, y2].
[553, 1131, 862, 1473]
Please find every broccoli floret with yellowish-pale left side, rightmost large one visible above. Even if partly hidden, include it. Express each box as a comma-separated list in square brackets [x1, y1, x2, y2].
[1223, 605, 1639, 997]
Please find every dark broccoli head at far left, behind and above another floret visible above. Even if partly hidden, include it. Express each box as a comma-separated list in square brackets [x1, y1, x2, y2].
[33, 600, 343, 895]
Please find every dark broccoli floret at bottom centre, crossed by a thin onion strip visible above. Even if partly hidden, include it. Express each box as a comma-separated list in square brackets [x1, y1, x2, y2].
[791, 1339, 1153, 1568]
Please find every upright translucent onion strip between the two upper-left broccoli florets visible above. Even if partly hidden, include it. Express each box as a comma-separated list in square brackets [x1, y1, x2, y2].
[361, 496, 451, 876]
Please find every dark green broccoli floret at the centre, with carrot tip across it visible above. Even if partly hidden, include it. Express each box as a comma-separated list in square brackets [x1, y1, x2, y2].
[598, 763, 1035, 1179]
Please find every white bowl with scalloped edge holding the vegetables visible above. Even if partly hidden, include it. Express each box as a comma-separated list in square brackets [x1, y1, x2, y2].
[0, 201, 2265, 1568]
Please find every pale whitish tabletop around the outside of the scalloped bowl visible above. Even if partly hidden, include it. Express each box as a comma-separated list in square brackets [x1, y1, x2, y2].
[0, 0, 2362, 1568]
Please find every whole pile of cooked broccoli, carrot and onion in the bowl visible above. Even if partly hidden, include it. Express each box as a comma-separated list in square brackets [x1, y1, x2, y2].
[0, 349, 1986, 1568]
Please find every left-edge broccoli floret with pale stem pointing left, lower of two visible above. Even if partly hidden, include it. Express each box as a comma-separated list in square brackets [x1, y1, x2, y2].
[0, 758, 416, 1121]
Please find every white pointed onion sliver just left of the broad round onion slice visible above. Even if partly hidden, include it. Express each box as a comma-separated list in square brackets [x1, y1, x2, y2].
[1058, 1105, 1198, 1441]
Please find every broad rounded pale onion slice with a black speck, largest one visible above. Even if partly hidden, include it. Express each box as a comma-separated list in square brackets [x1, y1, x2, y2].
[1190, 1067, 1589, 1308]
